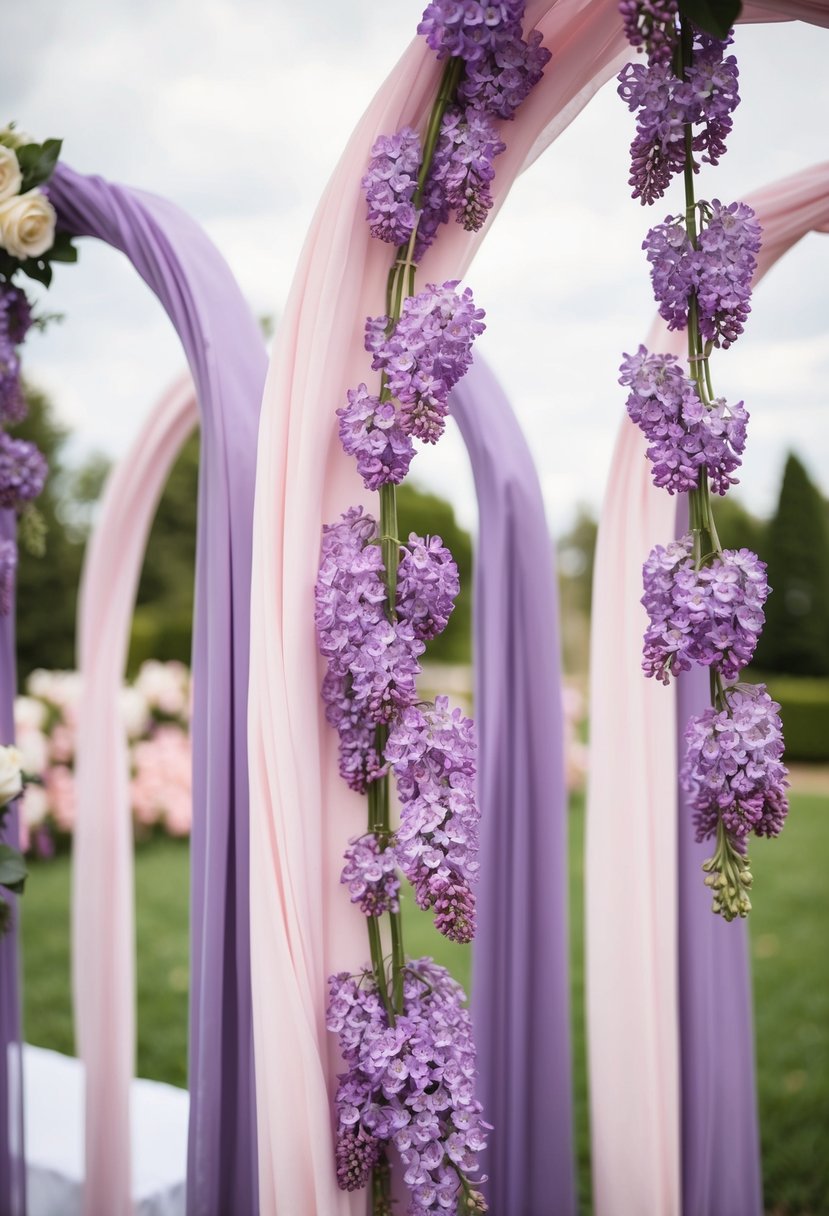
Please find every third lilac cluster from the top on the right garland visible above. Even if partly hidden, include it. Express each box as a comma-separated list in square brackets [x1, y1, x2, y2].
[620, 347, 749, 494]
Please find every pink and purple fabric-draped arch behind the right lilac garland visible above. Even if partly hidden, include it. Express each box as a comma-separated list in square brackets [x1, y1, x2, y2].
[586, 163, 829, 1216]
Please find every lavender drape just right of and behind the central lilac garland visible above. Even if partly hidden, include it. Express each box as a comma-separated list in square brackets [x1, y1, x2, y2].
[451, 359, 576, 1216]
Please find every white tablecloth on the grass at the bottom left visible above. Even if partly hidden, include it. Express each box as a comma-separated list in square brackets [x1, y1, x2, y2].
[23, 1043, 190, 1216]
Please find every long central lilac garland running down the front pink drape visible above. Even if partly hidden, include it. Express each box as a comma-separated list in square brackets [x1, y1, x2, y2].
[315, 0, 549, 1216]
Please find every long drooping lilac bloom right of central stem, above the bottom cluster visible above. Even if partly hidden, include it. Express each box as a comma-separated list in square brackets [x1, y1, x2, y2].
[385, 697, 479, 942]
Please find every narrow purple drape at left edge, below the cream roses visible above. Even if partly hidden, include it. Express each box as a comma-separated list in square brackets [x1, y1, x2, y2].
[0, 511, 26, 1216]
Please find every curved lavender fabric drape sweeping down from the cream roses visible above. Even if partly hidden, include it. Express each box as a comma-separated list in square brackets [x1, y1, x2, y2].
[50, 167, 266, 1216]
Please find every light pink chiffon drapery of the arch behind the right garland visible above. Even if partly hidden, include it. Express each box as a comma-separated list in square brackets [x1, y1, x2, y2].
[586, 164, 829, 1216]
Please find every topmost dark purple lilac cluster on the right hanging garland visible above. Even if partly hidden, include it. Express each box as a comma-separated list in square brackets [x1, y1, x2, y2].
[619, 14, 740, 204]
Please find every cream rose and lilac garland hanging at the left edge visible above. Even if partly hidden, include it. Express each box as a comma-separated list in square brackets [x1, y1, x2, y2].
[0, 124, 77, 933]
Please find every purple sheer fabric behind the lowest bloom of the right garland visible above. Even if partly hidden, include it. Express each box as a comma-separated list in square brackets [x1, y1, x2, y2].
[677, 669, 763, 1216]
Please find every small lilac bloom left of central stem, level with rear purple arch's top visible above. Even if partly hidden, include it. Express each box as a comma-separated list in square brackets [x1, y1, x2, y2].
[337, 384, 415, 490]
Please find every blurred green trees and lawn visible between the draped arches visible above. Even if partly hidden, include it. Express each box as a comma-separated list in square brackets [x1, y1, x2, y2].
[12, 393, 829, 1216]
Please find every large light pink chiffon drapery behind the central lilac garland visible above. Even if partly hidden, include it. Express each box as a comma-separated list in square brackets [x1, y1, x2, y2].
[249, 0, 829, 1216]
